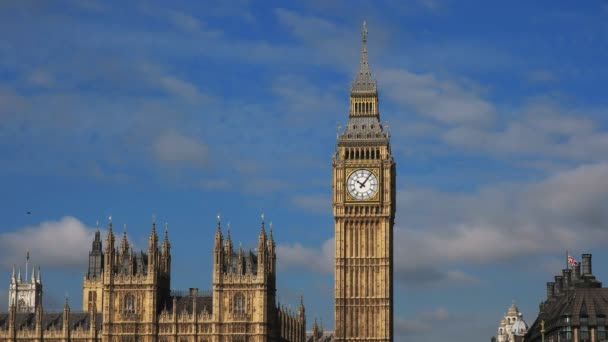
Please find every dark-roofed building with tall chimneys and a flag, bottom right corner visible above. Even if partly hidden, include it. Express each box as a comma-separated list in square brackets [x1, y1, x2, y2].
[525, 254, 608, 342]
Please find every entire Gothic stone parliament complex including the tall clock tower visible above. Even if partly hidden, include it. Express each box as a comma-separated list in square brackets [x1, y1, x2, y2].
[0, 23, 396, 342]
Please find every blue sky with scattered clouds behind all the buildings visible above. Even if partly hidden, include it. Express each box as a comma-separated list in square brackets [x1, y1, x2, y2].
[0, 0, 608, 341]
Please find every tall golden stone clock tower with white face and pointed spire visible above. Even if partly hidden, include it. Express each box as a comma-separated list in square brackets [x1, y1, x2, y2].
[333, 22, 395, 342]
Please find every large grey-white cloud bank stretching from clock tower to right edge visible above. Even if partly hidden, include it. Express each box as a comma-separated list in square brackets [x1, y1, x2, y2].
[395, 163, 608, 270]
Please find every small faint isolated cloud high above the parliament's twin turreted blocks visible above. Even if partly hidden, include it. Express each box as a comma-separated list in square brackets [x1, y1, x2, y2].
[154, 130, 209, 167]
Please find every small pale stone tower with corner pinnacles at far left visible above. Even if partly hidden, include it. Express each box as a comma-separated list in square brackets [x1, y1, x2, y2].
[8, 252, 42, 313]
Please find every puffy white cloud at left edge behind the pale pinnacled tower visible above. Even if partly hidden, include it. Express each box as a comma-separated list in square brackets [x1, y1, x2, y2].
[0, 216, 95, 269]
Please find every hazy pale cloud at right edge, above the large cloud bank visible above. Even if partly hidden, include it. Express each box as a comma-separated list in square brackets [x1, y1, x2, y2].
[441, 100, 608, 161]
